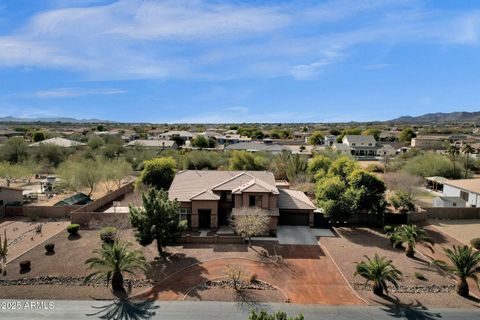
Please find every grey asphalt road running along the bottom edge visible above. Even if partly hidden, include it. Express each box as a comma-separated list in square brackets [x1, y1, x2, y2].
[0, 300, 480, 320]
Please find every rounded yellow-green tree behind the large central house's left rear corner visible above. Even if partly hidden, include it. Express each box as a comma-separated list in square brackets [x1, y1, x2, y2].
[139, 157, 177, 189]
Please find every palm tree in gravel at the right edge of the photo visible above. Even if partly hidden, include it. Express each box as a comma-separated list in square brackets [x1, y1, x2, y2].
[434, 246, 480, 297]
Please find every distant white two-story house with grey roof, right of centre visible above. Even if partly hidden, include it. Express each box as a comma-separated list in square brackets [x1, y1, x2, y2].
[333, 135, 397, 158]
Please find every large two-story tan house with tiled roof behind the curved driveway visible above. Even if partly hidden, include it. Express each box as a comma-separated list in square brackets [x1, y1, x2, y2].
[169, 170, 316, 232]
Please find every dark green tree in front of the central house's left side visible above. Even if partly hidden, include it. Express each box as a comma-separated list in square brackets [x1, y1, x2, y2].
[130, 188, 182, 256]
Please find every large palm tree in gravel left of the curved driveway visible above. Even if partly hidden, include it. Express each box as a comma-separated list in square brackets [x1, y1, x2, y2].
[85, 241, 148, 293]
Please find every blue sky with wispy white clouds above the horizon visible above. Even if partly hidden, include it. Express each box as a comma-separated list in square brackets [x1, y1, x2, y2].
[0, 0, 480, 123]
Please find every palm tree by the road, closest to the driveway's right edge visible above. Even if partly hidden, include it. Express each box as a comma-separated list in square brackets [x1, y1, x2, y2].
[354, 254, 402, 295]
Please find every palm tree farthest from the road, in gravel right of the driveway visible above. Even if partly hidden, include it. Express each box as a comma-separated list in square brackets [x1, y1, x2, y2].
[392, 224, 433, 258]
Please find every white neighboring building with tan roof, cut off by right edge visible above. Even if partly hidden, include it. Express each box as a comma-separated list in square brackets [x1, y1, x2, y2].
[427, 177, 480, 207]
